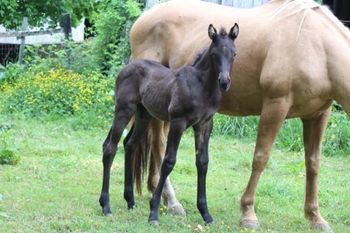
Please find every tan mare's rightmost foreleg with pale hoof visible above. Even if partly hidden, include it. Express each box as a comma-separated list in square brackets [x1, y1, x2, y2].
[302, 108, 330, 231]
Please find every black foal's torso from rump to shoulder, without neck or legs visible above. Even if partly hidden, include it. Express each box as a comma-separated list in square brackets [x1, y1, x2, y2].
[115, 60, 202, 121]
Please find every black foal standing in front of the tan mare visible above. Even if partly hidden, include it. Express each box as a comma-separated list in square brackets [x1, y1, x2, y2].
[100, 24, 239, 223]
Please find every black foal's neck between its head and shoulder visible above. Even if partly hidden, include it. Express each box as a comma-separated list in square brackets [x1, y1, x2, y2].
[193, 48, 219, 91]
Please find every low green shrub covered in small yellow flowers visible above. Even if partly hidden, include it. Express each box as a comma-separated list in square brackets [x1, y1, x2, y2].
[0, 67, 113, 116]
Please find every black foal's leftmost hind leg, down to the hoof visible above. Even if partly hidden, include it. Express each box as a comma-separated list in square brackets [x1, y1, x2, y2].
[99, 103, 136, 215]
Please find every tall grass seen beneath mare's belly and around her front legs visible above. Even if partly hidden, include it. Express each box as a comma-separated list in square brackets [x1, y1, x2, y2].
[213, 108, 350, 156]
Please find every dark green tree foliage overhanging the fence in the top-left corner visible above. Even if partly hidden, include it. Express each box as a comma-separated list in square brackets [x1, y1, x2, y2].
[0, 0, 96, 29]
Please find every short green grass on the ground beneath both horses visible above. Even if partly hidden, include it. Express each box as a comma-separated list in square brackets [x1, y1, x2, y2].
[0, 116, 350, 233]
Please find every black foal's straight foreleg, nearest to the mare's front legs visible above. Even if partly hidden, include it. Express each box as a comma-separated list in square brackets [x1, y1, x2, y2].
[193, 119, 214, 224]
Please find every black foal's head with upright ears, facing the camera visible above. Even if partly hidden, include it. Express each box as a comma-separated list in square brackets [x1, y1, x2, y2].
[208, 23, 239, 91]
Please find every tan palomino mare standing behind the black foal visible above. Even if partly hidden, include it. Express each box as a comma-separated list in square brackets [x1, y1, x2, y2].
[130, 0, 350, 230]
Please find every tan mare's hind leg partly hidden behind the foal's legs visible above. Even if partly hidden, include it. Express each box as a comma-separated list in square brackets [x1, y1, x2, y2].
[148, 119, 185, 215]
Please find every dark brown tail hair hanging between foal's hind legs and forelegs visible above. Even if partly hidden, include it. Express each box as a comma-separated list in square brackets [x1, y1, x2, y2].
[124, 123, 150, 194]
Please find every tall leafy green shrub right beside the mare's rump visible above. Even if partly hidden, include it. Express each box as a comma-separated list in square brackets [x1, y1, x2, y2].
[93, 0, 141, 76]
